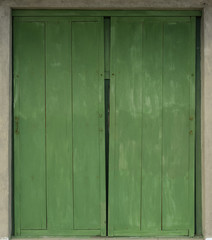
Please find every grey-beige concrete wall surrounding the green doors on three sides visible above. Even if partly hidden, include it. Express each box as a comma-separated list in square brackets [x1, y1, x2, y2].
[0, 0, 212, 239]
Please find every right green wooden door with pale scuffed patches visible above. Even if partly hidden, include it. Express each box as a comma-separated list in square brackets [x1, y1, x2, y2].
[108, 17, 195, 236]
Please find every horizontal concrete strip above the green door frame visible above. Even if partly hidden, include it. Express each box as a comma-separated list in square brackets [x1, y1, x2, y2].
[0, 0, 211, 9]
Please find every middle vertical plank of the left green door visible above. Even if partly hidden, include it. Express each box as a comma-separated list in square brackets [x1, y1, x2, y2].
[46, 20, 73, 230]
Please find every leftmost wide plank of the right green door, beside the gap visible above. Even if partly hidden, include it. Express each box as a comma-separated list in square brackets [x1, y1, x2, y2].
[109, 17, 142, 236]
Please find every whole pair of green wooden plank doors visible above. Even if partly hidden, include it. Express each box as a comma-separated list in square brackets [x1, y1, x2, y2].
[13, 17, 195, 236]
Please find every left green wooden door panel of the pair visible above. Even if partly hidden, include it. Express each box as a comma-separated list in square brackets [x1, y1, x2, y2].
[13, 17, 106, 236]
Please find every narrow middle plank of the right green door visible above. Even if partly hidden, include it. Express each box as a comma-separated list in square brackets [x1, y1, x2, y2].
[141, 19, 163, 231]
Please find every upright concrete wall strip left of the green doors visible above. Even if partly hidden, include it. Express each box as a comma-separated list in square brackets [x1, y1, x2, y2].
[0, 4, 11, 237]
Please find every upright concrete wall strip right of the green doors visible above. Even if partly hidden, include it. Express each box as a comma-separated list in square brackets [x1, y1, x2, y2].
[202, 6, 212, 238]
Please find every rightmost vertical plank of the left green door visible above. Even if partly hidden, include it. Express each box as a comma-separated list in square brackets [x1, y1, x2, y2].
[72, 21, 104, 229]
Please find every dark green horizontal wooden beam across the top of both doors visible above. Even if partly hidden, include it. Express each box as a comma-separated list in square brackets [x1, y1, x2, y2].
[12, 9, 202, 17]
